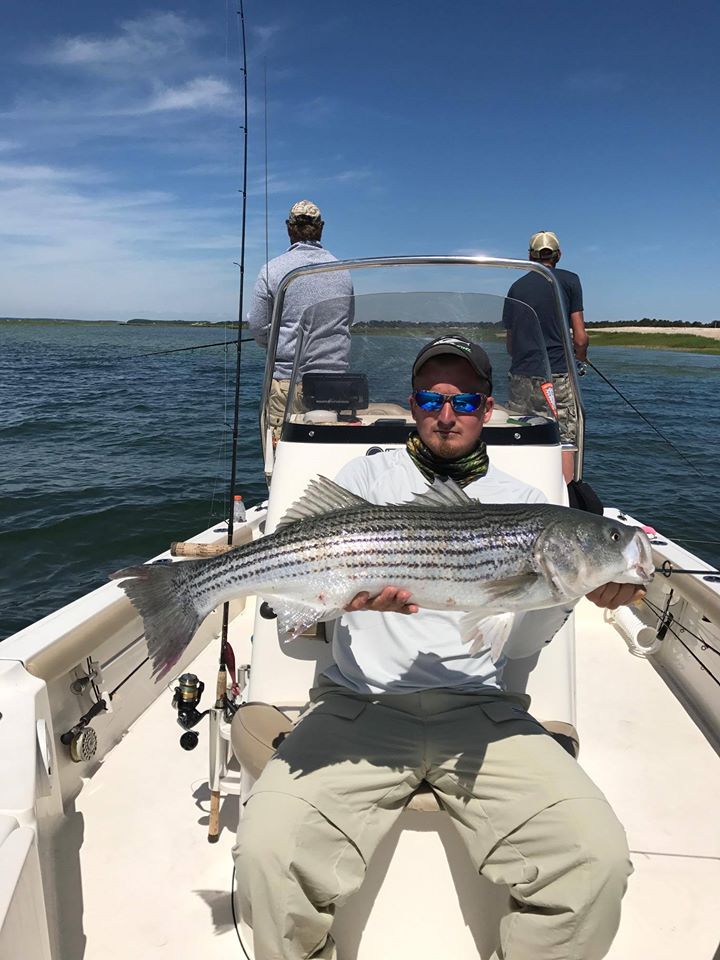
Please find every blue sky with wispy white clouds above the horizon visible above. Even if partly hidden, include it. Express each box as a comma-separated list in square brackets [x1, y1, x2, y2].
[0, 0, 720, 321]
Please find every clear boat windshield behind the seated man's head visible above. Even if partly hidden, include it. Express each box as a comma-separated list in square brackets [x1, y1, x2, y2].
[278, 291, 559, 443]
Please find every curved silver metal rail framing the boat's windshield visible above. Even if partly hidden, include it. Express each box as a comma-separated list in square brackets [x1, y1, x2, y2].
[259, 255, 585, 480]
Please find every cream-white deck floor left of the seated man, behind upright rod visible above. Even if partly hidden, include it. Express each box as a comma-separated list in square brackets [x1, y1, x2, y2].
[73, 604, 254, 960]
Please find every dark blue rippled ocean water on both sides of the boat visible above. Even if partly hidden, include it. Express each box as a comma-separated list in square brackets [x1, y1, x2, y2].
[0, 322, 720, 638]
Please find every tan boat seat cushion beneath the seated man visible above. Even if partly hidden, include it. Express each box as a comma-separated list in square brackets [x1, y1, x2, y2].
[230, 701, 580, 813]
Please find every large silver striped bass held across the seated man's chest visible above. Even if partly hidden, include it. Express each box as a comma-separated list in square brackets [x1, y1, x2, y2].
[112, 477, 654, 676]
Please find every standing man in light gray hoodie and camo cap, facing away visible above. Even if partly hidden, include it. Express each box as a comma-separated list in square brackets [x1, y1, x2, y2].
[247, 200, 353, 437]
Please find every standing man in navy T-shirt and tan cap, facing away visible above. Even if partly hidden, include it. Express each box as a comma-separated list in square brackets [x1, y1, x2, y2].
[507, 230, 588, 483]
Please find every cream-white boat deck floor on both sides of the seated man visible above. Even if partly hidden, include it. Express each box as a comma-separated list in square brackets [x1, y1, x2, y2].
[76, 603, 720, 960]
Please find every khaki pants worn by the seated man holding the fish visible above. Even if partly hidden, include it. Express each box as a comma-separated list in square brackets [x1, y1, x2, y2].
[234, 683, 632, 960]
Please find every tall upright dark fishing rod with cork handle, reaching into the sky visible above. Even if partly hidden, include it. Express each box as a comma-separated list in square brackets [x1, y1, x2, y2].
[208, 0, 248, 843]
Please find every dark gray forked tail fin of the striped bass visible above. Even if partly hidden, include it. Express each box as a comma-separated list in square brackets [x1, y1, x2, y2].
[110, 560, 209, 679]
